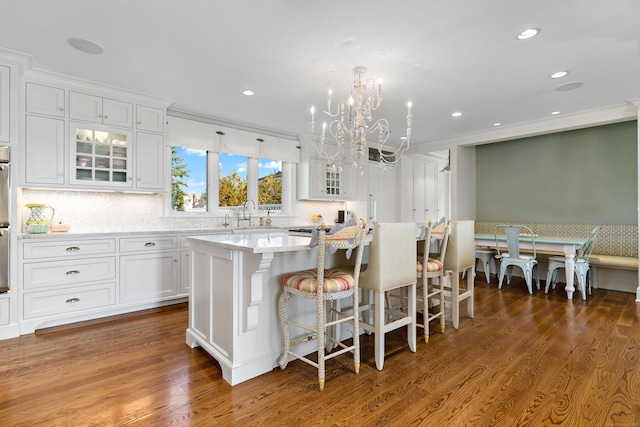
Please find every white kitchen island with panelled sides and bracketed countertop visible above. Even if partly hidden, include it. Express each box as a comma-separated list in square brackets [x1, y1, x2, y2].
[186, 232, 352, 385]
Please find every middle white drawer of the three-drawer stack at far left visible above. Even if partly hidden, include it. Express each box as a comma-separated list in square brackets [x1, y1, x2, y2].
[23, 256, 116, 290]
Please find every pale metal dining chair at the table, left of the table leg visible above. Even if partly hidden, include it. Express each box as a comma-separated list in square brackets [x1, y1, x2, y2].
[493, 224, 540, 294]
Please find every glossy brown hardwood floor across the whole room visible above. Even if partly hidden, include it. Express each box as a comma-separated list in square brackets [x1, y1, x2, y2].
[0, 275, 640, 426]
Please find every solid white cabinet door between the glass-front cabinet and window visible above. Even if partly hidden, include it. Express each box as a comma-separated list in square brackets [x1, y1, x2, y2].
[134, 132, 165, 191]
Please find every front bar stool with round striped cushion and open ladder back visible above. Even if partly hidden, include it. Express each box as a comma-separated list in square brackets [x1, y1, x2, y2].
[278, 225, 364, 391]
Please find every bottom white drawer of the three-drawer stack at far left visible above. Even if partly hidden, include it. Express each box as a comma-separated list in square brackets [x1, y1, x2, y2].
[24, 282, 116, 319]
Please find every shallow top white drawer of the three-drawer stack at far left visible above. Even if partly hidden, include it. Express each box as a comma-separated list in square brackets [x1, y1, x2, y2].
[22, 239, 116, 259]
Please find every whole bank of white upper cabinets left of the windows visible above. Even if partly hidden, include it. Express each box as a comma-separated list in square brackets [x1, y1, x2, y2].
[22, 78, 168, 192]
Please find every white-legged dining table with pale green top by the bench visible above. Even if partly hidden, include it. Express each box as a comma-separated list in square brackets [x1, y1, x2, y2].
[475, 234, 587, 299]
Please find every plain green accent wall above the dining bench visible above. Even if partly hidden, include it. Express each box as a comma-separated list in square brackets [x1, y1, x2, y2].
[476, 121, 638, 224]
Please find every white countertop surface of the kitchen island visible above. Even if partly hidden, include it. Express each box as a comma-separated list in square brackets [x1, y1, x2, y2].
[188, 232, 311, 253]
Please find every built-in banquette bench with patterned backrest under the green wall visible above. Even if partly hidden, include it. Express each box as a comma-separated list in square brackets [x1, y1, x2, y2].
[475, 222, 640, 293]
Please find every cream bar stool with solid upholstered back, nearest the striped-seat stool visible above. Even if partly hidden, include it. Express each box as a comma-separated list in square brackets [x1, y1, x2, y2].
[360, 222, 417, 370]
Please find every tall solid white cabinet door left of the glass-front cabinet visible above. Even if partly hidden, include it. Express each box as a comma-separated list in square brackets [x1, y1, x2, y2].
[23, 115, 65, 186]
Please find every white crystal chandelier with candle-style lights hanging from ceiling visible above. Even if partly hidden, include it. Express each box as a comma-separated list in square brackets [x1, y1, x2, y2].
[309, 67, 413, 170]
